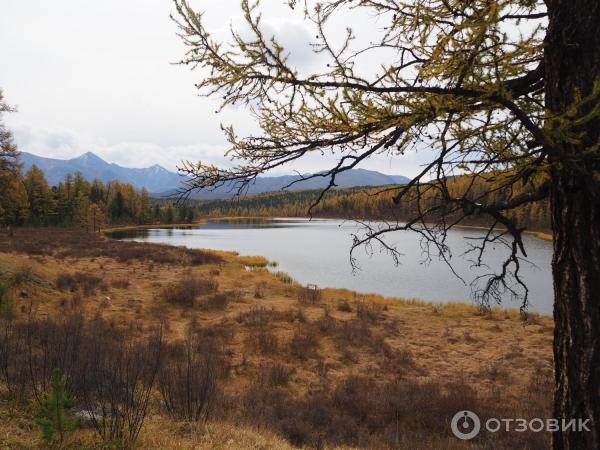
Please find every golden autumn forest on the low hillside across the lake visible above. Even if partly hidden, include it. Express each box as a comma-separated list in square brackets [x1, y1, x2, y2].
[198, 176, 550, 231]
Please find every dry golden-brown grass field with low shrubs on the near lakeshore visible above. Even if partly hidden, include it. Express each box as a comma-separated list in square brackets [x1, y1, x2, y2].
[0, 229, 552, 449]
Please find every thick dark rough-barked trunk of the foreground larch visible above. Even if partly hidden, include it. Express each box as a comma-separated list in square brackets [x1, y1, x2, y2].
[545, 0, 600, 450]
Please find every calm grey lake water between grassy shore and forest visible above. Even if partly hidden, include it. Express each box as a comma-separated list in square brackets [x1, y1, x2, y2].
[106, 219, 552, 314]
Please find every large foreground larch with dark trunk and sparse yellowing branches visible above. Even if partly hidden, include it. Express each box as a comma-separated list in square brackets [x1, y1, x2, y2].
[175, 0, 600, 449]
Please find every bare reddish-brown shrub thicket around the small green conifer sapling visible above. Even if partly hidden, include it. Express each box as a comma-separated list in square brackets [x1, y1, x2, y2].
[0, 314, 162, 447]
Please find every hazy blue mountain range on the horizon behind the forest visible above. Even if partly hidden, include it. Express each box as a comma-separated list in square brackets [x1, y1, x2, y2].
[21, 152, 410, 200]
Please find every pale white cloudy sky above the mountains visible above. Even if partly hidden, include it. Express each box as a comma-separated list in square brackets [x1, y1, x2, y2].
[0, 0, 418, 176]
